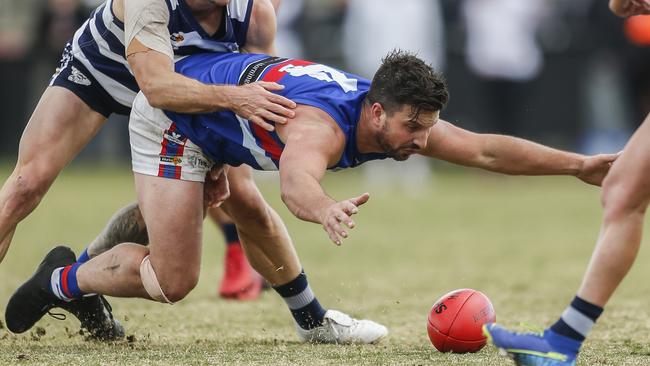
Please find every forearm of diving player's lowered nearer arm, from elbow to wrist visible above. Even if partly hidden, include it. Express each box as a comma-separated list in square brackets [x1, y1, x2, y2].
[281, 173, 336, 224]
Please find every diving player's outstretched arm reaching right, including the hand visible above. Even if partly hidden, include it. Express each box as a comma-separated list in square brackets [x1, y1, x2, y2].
[423, 120, 618, 185]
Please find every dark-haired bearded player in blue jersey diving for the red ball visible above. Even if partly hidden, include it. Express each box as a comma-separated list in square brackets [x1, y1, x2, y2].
[6, 52, 616, 346]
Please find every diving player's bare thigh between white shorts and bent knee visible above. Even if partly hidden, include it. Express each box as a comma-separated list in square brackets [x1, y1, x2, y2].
[135, 173, 203, 283]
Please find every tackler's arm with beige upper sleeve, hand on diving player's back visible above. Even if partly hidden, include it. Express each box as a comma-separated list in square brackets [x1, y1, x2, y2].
[124, 0, 295, 130]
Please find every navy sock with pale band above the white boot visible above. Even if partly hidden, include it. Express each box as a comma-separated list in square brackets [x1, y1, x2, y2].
[273, 271, 326, 329]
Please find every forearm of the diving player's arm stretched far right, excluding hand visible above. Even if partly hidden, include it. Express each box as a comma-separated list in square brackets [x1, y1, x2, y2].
[476, 135, 585, 175]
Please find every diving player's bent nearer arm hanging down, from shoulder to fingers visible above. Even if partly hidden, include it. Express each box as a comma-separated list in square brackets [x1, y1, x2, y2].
[280, 107, 370, 245]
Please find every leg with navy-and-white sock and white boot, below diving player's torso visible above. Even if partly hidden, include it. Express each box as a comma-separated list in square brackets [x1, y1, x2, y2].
[223, 169, 388, 344]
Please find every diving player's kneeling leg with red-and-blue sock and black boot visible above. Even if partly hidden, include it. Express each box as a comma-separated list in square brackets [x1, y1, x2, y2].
[6, 174, 203, 335]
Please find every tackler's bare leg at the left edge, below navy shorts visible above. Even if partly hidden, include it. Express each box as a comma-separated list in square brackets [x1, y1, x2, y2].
[0, 86, 106, 262]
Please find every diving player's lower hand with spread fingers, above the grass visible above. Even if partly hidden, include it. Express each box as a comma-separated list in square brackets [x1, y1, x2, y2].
[321, 193, 370, 245]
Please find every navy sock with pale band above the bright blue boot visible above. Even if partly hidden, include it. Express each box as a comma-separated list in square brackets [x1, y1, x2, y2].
[551, 296, 603, 343]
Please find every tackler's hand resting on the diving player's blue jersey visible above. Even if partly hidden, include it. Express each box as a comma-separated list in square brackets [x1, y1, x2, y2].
[228, 81, 296, 131]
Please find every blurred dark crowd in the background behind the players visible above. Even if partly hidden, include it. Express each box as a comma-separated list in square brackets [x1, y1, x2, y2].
[0, 0, 650, 160]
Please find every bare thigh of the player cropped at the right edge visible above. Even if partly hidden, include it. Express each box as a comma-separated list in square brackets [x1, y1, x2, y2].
[603, 115, 650, 209]
